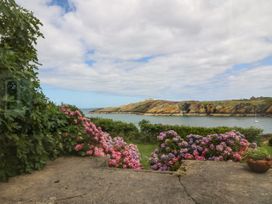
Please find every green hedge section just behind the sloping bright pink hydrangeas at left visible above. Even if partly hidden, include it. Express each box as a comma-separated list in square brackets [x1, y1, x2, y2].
[90, 118, 140, 142]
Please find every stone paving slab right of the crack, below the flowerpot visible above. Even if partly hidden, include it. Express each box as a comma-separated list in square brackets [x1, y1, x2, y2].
[177, 160, 272, 204]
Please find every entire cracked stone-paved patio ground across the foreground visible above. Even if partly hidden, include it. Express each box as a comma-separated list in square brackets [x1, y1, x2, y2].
[0, 157, 272, 204]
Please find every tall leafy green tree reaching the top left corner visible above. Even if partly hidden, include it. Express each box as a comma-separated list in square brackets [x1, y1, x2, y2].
[0, 0, 58, 180]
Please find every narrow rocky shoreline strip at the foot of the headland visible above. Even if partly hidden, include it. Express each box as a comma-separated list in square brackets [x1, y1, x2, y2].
[88, 111, 272, 118]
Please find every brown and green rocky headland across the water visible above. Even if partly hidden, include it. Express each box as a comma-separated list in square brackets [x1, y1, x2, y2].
[93, 97, 272, 116]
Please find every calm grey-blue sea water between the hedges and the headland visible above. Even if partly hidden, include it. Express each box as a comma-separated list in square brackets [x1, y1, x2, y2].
[82, 109, 272, 133]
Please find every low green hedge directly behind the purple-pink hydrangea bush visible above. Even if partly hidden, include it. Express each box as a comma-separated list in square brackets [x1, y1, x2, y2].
[139, 120, 262, 143]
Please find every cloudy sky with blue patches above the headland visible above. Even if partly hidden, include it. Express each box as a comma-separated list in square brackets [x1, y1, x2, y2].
[16, 0, 272, 108]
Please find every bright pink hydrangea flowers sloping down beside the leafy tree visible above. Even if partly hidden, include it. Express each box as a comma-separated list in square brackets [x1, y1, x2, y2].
[61, 106, 141, 169]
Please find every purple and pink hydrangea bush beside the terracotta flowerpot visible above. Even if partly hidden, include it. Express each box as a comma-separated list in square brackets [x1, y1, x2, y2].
[150, 130, 256, 171]
